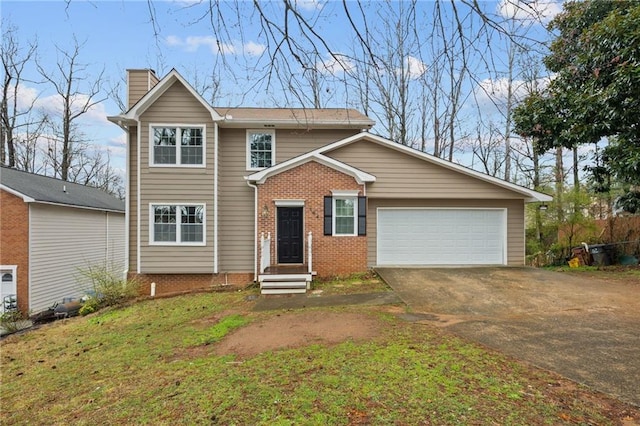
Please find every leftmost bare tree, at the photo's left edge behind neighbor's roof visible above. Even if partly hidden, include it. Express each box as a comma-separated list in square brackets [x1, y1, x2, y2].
[0, 22, 37, 167]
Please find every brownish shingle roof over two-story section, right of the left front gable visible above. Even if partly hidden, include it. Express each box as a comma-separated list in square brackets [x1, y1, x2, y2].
[215, 107, 375, 130]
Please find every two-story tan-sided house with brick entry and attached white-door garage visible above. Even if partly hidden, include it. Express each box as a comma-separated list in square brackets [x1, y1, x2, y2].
[109, 70, 551, 293]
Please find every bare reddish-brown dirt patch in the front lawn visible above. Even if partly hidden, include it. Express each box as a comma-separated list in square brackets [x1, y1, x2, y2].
[215, 311, 382, 358]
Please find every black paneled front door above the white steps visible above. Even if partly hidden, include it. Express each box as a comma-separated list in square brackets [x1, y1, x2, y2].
[278, 207, 304, 263]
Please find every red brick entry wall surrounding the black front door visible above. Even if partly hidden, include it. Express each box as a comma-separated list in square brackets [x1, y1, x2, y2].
[258, 161, 367, 277]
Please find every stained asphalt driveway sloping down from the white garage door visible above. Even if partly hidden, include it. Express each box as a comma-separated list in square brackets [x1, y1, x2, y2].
[377, 267, 640, 406]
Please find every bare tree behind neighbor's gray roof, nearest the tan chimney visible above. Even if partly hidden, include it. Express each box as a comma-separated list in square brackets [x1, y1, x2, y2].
[38, 38, 106, 180]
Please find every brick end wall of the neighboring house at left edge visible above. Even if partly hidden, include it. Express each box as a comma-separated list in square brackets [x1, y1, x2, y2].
[0, 190, 29, 313]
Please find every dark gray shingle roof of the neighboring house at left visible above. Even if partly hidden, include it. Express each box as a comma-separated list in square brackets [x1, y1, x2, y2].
[0, 166, 124, 213]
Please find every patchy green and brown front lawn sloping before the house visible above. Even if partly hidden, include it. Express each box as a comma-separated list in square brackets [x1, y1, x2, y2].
[0, 277, 638, 425]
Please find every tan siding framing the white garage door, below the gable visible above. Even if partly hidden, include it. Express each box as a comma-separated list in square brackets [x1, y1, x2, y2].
[367, 199, 525, 267]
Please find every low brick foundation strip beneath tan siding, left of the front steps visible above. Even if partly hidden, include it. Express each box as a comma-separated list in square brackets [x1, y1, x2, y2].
[129, 272, 253, 296]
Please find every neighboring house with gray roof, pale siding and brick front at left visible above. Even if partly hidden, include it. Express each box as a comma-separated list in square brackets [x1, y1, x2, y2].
[0, 167, 125, 313]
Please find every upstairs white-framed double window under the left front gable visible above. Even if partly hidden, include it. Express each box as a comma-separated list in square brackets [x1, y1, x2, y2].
[151, 126, 205, 166]
